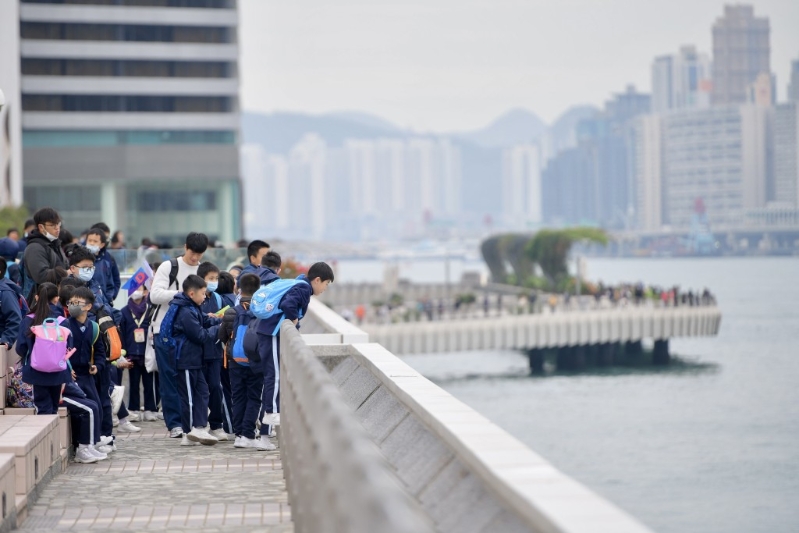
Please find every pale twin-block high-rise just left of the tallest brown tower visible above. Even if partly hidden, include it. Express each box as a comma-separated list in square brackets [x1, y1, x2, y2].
[652, 46, 712, 113]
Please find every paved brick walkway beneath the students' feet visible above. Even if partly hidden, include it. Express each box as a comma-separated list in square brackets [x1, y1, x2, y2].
[17, 421, 293, 533]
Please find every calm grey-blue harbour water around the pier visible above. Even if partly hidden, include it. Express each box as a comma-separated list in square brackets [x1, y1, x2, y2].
[338, 258, 799, 533]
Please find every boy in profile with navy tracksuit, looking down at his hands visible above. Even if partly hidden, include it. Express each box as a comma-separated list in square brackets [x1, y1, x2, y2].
[169, 274, 220, 446]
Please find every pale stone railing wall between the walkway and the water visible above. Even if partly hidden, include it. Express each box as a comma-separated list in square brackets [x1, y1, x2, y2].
[288, 301, 650, 533]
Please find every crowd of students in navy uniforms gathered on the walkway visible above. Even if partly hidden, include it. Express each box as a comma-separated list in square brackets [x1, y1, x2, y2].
[0, 208, 333, 463]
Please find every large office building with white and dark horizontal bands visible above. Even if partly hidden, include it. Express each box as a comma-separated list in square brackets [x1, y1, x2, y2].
[5, 0, 241, 244]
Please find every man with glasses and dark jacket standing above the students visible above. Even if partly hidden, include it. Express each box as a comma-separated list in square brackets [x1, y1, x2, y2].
[22, 207, 68, 301]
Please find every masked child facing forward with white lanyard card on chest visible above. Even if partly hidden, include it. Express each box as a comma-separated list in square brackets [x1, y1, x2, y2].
[119, 287, 159, 422]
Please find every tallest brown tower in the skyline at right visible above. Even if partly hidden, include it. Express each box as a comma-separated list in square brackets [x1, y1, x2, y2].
[712, 5, 771, 105]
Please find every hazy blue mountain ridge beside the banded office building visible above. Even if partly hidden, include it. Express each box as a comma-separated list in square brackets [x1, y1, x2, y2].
[241, 111, 405, 154]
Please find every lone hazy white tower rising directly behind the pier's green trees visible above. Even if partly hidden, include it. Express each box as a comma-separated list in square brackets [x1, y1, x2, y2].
[502, 144, 542, 230]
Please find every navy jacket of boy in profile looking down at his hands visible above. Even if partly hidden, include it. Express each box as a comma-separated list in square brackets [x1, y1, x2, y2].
[169, 292, 220, 370]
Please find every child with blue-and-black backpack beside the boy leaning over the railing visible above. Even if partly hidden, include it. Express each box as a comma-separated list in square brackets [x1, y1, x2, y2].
[219, 274, 275, 451]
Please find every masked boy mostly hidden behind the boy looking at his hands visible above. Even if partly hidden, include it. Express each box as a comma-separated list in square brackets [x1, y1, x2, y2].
[197, 261, 233, 441]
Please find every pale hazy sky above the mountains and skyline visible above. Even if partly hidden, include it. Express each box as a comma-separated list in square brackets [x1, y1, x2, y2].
[239, 0, 799, 132]
